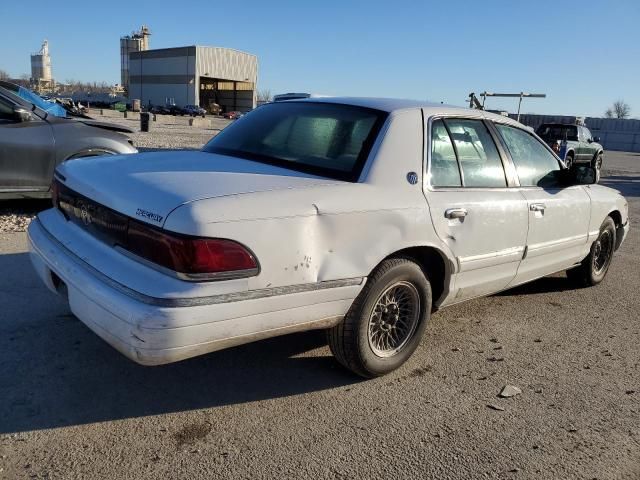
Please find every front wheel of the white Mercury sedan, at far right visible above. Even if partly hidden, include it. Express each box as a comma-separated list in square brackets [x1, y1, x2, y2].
[567, 217, 616, 287]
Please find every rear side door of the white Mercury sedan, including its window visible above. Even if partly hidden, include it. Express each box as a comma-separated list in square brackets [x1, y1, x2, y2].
[425, 117, 528, 304]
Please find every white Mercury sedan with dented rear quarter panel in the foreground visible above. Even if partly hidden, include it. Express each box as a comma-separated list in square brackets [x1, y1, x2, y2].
[29, 98, 629, 377]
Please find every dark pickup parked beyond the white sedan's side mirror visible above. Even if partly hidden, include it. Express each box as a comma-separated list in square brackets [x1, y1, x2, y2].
[536, 123, 604, 181]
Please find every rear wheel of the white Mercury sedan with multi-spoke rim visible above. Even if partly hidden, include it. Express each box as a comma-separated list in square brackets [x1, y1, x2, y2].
[327, 258, 431, 378]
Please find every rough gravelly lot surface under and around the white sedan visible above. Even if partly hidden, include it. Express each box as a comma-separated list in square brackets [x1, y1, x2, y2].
[0, 147, 640, 479]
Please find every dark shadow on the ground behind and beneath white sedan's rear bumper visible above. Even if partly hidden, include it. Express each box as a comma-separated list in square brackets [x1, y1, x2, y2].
[0, 253, 360, 433]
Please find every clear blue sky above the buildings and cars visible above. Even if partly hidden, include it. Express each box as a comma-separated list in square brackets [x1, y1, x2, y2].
[0, 0, 640, 117]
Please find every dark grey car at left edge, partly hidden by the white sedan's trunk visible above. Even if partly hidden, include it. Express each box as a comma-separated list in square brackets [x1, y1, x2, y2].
[0, 86, 137, 198]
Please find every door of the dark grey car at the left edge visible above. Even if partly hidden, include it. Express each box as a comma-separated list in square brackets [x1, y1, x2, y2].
[0, 95, 55, 192]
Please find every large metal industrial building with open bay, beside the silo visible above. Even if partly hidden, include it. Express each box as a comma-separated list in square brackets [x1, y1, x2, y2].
[128, 46, 258, 111]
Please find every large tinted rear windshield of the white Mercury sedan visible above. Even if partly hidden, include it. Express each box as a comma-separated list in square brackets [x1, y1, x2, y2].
[203, 101, 387, 181]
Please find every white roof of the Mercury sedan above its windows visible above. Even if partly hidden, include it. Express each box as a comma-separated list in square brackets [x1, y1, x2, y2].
[296, 97, 523, 127]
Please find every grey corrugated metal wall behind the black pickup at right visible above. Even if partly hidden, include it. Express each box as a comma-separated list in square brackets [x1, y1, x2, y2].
[509, 114, 640, 152]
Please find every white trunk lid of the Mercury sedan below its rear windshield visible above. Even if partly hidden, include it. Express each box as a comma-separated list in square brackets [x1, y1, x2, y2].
[56, 151, 343, 226]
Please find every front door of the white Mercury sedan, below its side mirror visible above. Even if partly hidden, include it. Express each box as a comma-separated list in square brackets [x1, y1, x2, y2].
[496, 124, 591, 285]
